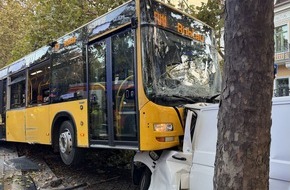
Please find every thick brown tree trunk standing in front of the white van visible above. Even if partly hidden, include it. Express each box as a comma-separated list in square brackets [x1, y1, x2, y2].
[214, 0, 274, 190]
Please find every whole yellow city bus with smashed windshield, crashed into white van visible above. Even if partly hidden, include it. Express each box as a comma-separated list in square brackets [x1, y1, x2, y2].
[0, 0, 220, 165]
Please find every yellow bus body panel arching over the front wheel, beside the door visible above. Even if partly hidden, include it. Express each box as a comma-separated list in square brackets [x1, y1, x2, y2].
[50, 100, 89, 147]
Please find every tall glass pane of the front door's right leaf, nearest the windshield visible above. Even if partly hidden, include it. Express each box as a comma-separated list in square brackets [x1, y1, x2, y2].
[112, 30, 137, 141]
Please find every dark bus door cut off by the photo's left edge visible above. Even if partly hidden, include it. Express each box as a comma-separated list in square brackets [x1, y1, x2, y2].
[0, 79, 7, 139]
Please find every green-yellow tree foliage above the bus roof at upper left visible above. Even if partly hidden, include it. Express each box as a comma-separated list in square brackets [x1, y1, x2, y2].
[0, 0, 126, 66]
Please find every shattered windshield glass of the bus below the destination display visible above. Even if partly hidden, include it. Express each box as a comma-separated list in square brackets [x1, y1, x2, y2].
[142, 25, 220, 104]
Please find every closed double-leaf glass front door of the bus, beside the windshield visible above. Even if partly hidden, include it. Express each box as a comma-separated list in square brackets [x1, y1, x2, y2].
[88, 29, 138, 148]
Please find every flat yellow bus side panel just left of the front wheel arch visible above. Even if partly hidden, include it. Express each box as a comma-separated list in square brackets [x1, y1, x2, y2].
[25, 105, 51, 144]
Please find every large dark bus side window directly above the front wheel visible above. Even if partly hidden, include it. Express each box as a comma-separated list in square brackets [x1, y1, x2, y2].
[51, 45, 86, 103]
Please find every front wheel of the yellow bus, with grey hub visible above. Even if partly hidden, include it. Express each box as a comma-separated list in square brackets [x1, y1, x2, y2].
[59, 121, 80, 165]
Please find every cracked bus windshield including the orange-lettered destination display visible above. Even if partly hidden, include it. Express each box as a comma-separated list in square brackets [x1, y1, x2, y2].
[142, 0, 220, 105]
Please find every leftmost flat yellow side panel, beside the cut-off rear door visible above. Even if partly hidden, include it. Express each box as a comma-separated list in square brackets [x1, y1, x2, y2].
[6, 109, 26, 142]
